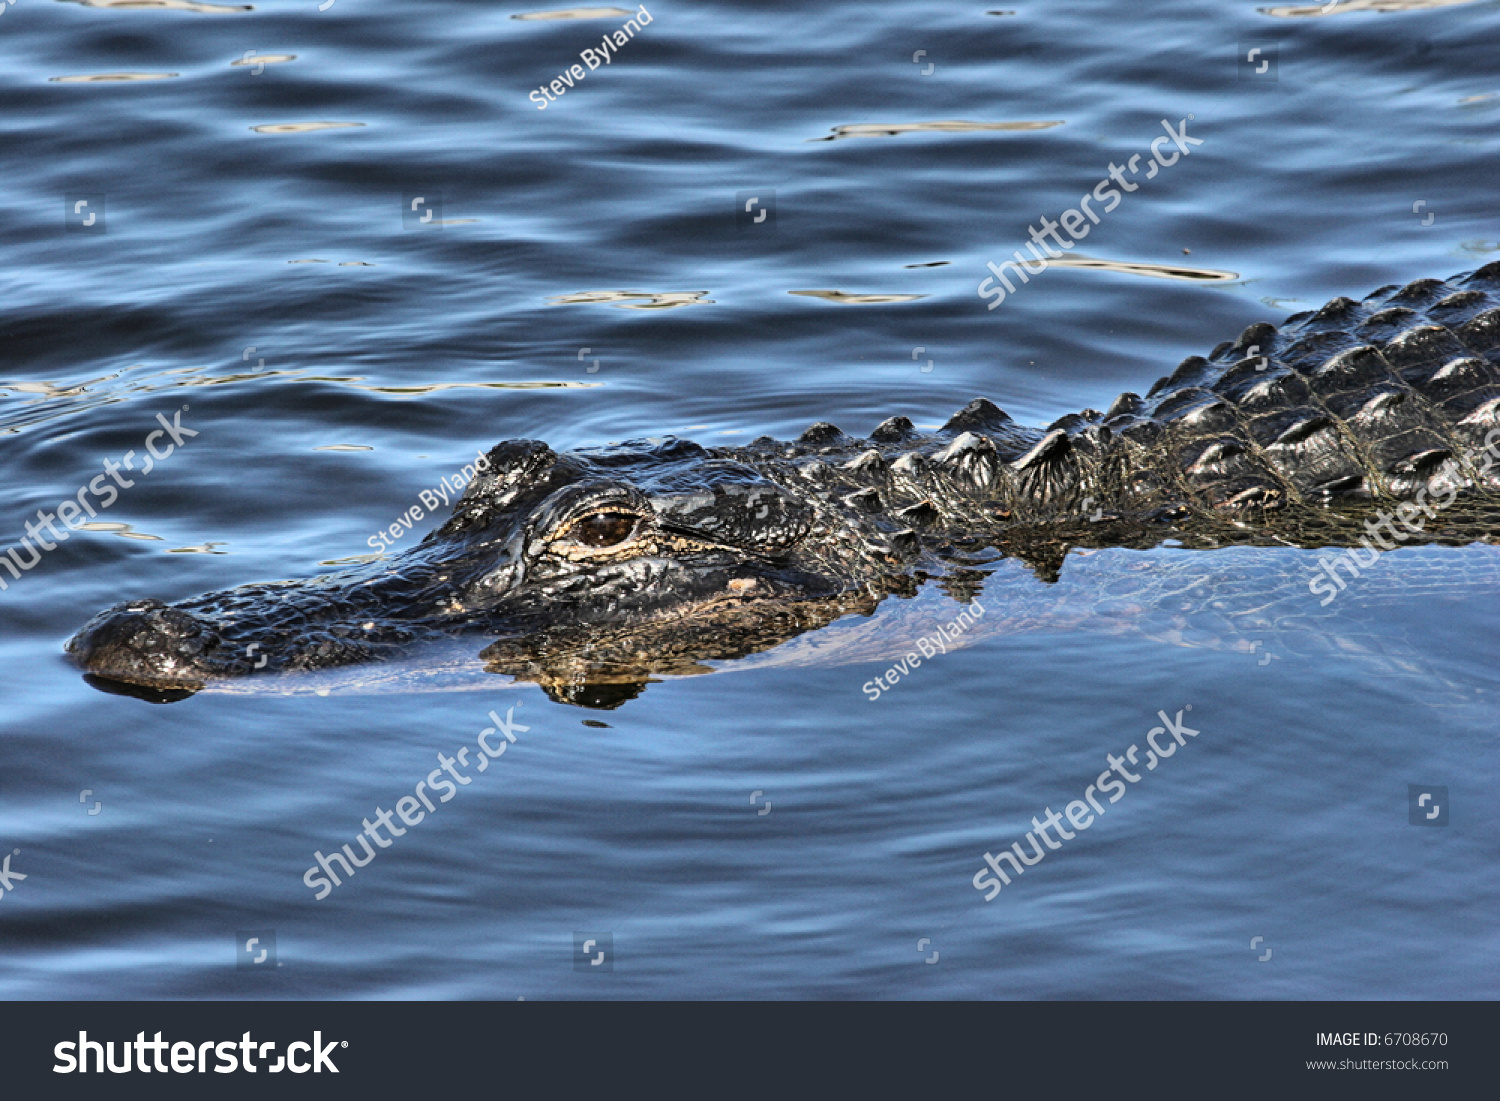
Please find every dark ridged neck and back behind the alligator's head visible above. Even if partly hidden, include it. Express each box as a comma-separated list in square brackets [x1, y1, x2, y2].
[716, 263, 1500, 549]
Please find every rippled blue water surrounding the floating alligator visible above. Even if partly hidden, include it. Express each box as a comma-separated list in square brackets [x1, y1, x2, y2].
[0, 0, 1500, 999]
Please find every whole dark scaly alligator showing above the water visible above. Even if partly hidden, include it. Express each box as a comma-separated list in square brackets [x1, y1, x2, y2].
[66, 261, 1500, 707]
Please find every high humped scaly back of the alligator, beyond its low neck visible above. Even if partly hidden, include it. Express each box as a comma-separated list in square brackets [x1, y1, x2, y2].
[1086, 263, 1500, 510]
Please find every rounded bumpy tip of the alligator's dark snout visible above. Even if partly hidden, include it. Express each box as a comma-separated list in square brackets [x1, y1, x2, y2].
[65, 600, 219, 690]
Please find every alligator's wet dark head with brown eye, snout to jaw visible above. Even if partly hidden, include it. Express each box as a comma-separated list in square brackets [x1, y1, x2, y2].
[66, 438, 900, 707]
